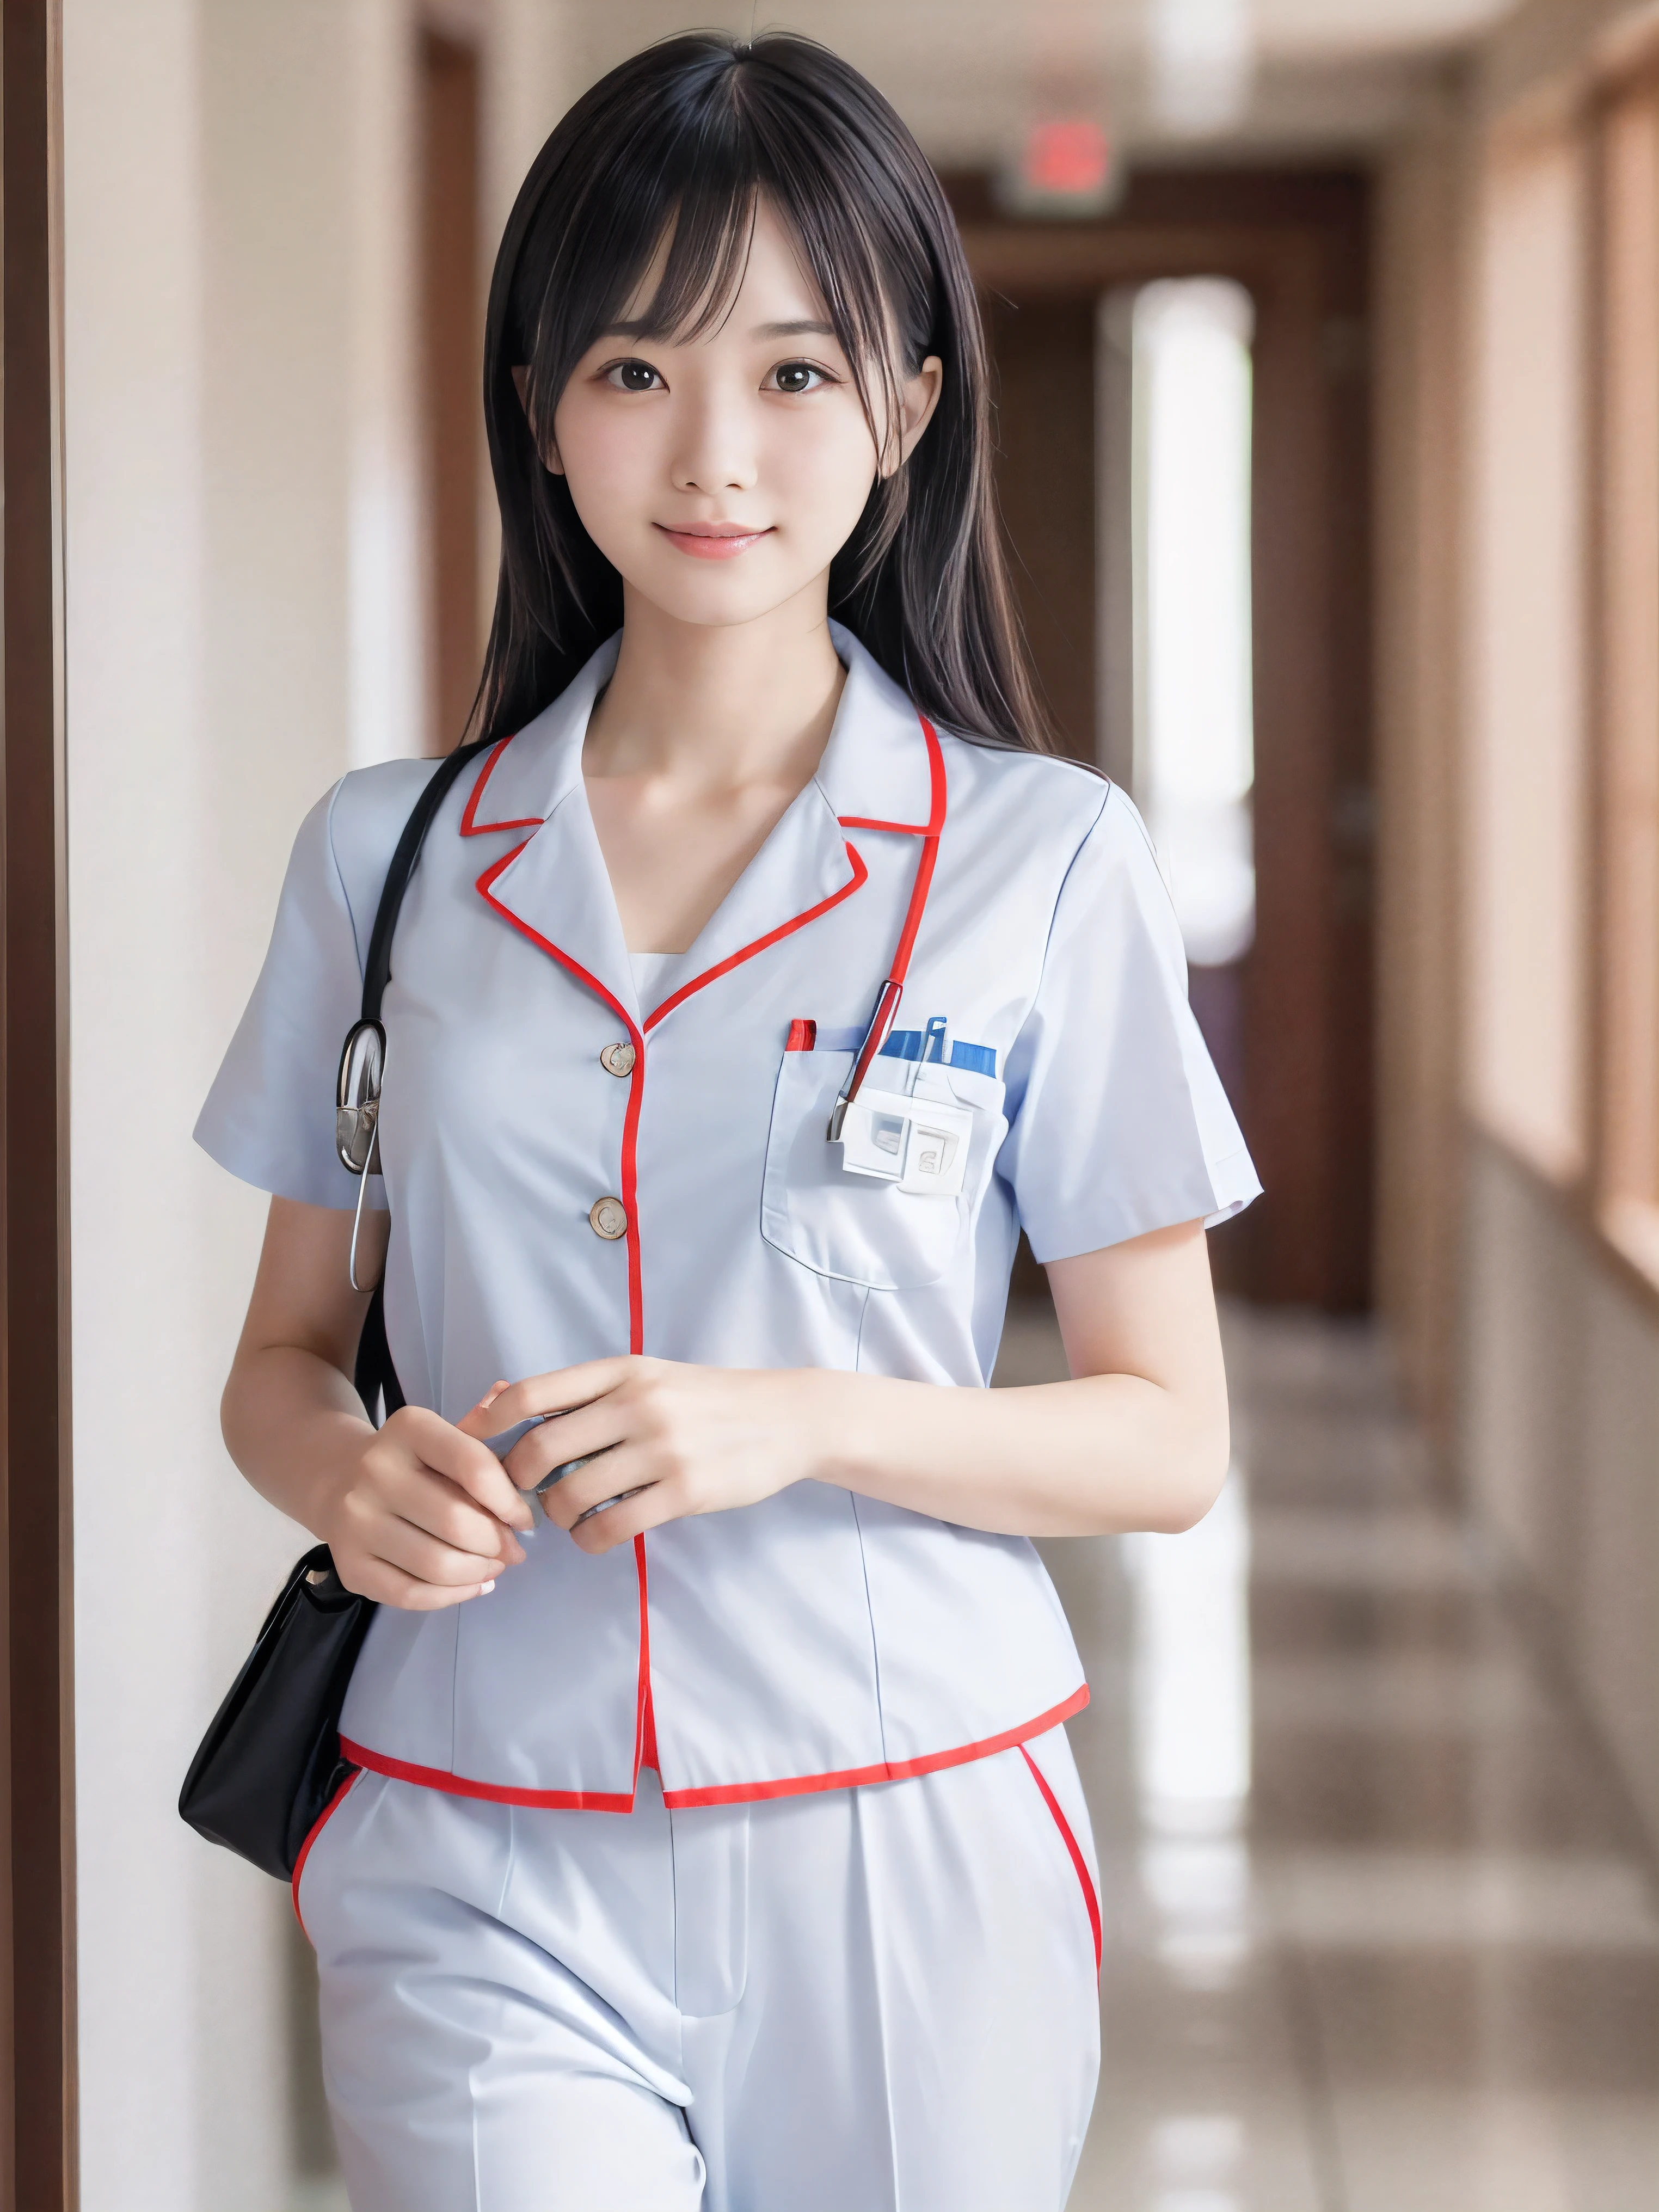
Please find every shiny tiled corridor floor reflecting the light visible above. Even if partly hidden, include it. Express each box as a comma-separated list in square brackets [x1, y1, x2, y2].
[998, 1312, 1659, 2212]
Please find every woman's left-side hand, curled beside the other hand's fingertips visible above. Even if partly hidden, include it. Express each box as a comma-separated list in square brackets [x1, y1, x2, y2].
[316, 1400, 533, 1613]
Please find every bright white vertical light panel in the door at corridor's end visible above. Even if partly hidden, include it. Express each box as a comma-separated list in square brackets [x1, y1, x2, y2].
[1133, 276, 1256, 967]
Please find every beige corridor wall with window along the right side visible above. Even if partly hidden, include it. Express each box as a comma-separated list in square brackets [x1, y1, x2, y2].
[1378, 0, 1659, 1838]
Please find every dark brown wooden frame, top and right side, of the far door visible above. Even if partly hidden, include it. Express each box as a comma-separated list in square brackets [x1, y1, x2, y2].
[944, 168, 1374, 1312]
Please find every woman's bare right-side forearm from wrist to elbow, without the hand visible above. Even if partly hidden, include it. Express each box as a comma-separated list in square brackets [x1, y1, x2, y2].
[805, 1372, 1228, 1535]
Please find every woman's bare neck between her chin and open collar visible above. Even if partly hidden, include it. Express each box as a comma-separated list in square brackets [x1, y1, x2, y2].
[584, 588, 843, 788]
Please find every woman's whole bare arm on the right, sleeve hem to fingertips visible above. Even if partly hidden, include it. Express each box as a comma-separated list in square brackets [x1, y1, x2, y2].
[480, 1221, 1228, 1553]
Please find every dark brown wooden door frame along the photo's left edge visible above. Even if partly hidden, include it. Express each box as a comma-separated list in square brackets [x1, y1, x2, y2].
[0, 0, 77, 2212]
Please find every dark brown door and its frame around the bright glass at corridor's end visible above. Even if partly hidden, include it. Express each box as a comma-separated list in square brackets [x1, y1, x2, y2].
[947, 170, 1372, 1312]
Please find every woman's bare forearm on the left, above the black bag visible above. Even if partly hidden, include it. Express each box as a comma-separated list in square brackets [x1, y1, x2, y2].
[219, 1345, 374, 1535]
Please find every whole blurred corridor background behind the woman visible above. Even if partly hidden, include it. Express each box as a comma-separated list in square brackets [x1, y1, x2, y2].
[62, 0, 1659, 2212]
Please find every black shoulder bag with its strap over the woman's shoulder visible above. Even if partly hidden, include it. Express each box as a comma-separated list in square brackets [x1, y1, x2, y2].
[179, 739, 484, 1880]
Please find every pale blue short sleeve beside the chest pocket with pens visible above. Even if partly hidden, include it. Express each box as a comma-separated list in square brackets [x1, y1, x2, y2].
[998, 785, 1261, 1261]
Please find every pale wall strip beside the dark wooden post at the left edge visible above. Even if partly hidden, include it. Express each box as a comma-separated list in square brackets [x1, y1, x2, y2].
[64, 0, 276, 2212]
